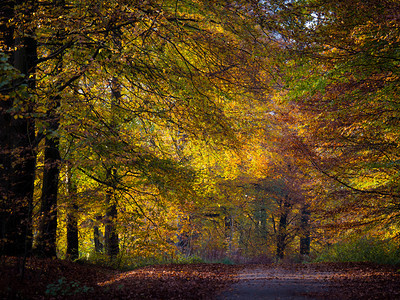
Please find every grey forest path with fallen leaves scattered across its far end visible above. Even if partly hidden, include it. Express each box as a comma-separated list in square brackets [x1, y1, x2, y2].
[217, 265, 335, 300]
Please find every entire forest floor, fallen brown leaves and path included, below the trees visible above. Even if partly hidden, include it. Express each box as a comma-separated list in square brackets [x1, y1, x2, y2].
[0, 257, 400, 300]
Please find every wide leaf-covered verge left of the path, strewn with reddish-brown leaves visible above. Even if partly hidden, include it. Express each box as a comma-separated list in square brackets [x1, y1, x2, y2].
[0, 257, 242, 299]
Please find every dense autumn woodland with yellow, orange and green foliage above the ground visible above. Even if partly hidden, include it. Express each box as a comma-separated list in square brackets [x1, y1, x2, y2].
[0, 0, 400, 266]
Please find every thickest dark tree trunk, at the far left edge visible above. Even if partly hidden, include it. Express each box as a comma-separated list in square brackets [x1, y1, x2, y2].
[0, 0, 37, 255]
